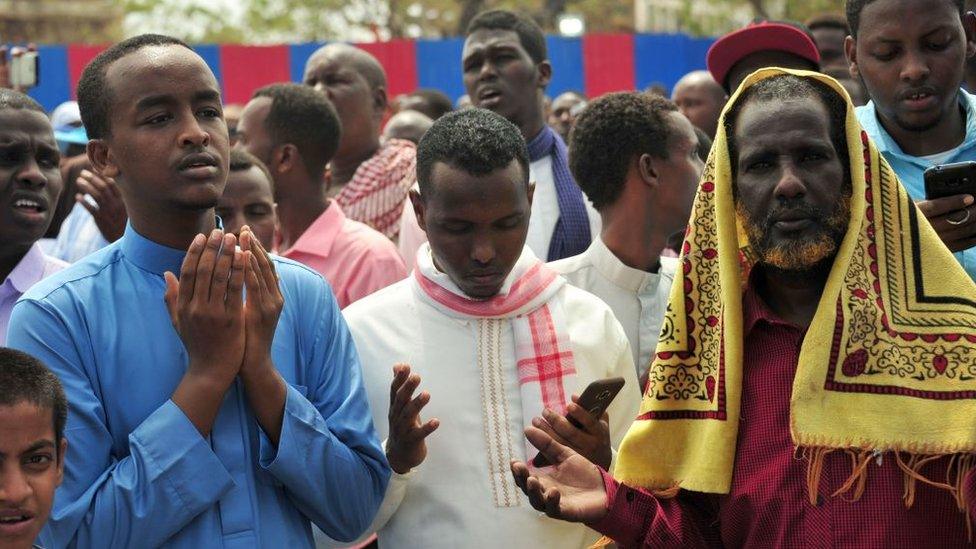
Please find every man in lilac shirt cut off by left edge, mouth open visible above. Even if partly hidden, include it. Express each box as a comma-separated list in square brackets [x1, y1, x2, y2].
[0, 88, 67, 346]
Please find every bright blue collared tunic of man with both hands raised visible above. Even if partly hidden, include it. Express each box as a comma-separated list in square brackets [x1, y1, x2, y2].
[7, 226, 390, 549]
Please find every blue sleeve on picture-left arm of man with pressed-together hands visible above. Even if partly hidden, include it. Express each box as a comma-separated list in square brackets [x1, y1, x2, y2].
[8, 301, 234, 547]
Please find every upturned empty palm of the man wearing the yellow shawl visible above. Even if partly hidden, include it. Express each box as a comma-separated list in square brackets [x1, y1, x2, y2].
[511, 427, 607, 523]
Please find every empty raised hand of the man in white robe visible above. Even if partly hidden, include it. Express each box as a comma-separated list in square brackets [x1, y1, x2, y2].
[386, 364, 440, 475]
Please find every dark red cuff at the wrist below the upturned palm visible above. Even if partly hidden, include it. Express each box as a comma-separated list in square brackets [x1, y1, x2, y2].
[589, 471, 657, 547]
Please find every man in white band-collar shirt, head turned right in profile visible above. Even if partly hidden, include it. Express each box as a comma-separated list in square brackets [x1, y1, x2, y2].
[550, 93, 702, 382]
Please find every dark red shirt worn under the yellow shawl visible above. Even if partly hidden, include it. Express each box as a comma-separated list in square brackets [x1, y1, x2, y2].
[591, 284, 976, 548]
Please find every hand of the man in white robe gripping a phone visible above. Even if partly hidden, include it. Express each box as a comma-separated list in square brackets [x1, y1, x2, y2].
[532, 377, 624, 469]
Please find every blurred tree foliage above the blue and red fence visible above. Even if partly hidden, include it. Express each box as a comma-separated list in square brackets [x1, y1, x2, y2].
[123, 0, 843, 43]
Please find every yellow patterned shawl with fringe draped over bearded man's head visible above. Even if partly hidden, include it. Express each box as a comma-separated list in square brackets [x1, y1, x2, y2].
[615, 69, 976, 496]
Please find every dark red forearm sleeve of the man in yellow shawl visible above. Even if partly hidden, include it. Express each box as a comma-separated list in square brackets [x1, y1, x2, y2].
[589, 471, 721, 548]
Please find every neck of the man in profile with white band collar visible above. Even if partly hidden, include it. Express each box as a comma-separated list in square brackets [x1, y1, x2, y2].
[600, 206, 668, 273]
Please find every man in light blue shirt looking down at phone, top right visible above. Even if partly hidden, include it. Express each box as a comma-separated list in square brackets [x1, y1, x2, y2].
[845, 0, 976, 280]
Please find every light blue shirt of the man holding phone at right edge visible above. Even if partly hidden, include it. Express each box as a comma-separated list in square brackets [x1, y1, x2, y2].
[857, 90, 976, 280]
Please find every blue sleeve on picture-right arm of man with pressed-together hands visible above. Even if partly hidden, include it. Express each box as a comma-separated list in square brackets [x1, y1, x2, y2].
[260, 281, 390, 541]
